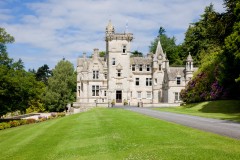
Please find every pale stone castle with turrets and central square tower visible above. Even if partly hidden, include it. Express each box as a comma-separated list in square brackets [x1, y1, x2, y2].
[74, 21, 197, 106]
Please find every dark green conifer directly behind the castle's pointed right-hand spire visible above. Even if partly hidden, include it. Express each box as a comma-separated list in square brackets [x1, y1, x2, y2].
[149, 27, 181, 65]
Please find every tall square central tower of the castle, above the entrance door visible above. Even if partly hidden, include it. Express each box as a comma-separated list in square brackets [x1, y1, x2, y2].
[105, 21, 133, 104]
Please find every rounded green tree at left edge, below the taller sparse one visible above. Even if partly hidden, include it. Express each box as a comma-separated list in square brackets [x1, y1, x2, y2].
[0, 66, 44, 115]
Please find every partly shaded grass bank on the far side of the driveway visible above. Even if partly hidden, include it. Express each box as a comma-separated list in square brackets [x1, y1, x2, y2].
[155, 100, 240, 122]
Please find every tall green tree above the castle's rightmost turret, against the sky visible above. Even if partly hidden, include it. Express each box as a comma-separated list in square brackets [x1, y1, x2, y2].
[181, 4, 226, 65]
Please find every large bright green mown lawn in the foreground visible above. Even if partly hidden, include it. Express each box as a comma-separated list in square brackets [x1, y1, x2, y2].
[0, 108, 240, 160]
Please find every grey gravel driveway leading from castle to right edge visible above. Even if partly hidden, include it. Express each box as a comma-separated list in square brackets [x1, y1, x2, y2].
[121, 107, 240, 139]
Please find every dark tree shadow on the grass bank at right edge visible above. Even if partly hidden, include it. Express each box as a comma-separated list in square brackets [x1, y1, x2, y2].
[199, 100, 240, 122]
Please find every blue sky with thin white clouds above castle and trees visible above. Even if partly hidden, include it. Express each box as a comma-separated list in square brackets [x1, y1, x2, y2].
[0, 0, 224, 69]
